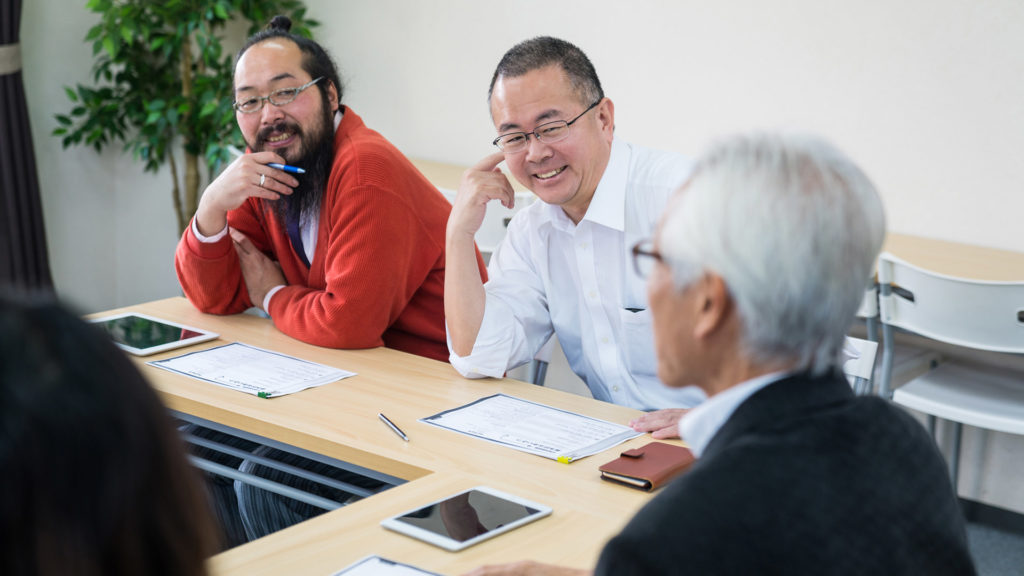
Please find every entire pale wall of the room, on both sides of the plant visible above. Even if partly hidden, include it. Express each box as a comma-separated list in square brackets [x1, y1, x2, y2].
[22, 0, 1024, 511]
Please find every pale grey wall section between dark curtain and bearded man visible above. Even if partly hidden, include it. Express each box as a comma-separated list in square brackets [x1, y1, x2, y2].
[22, 0, 180, 312]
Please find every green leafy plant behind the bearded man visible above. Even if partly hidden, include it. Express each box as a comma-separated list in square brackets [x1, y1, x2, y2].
[53, 0, 318, 231]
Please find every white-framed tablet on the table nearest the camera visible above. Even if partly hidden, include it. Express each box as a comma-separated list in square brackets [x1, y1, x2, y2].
[381, 486, 551, 551]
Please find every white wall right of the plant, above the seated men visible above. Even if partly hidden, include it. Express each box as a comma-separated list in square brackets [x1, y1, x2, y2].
[317, 0, 1024, 250]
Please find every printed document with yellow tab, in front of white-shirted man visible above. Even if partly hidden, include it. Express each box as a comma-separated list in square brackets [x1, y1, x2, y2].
[420, 394, 640, 463]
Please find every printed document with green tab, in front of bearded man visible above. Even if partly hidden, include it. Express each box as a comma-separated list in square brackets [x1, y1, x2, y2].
[148, 342, 355, 398]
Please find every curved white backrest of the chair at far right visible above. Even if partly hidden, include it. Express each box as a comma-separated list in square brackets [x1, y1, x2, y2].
[879, 252, 1024, 354]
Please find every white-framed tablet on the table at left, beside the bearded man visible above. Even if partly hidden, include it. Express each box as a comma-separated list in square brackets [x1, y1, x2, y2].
[90, 312, 218, 356]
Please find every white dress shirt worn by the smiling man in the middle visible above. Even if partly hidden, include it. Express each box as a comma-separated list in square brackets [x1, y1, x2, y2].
[449, 139, 705, 410]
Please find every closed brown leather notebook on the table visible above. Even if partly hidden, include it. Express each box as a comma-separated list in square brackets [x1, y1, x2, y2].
[598, 442, 694, 492]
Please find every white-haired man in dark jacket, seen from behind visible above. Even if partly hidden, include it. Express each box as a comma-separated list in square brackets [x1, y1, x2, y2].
[468, 135, 975, 576]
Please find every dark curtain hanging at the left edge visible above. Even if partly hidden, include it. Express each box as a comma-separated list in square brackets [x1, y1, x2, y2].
[0, 0, 53, 291]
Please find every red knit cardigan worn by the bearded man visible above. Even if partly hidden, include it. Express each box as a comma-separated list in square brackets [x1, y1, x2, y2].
[175, 109, 486, 362]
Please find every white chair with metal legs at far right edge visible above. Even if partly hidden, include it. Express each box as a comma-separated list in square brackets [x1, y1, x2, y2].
[879, 253, 1024, 487]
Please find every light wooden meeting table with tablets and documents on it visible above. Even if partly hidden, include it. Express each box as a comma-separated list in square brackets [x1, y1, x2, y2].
[103, 298, 663, 575]
